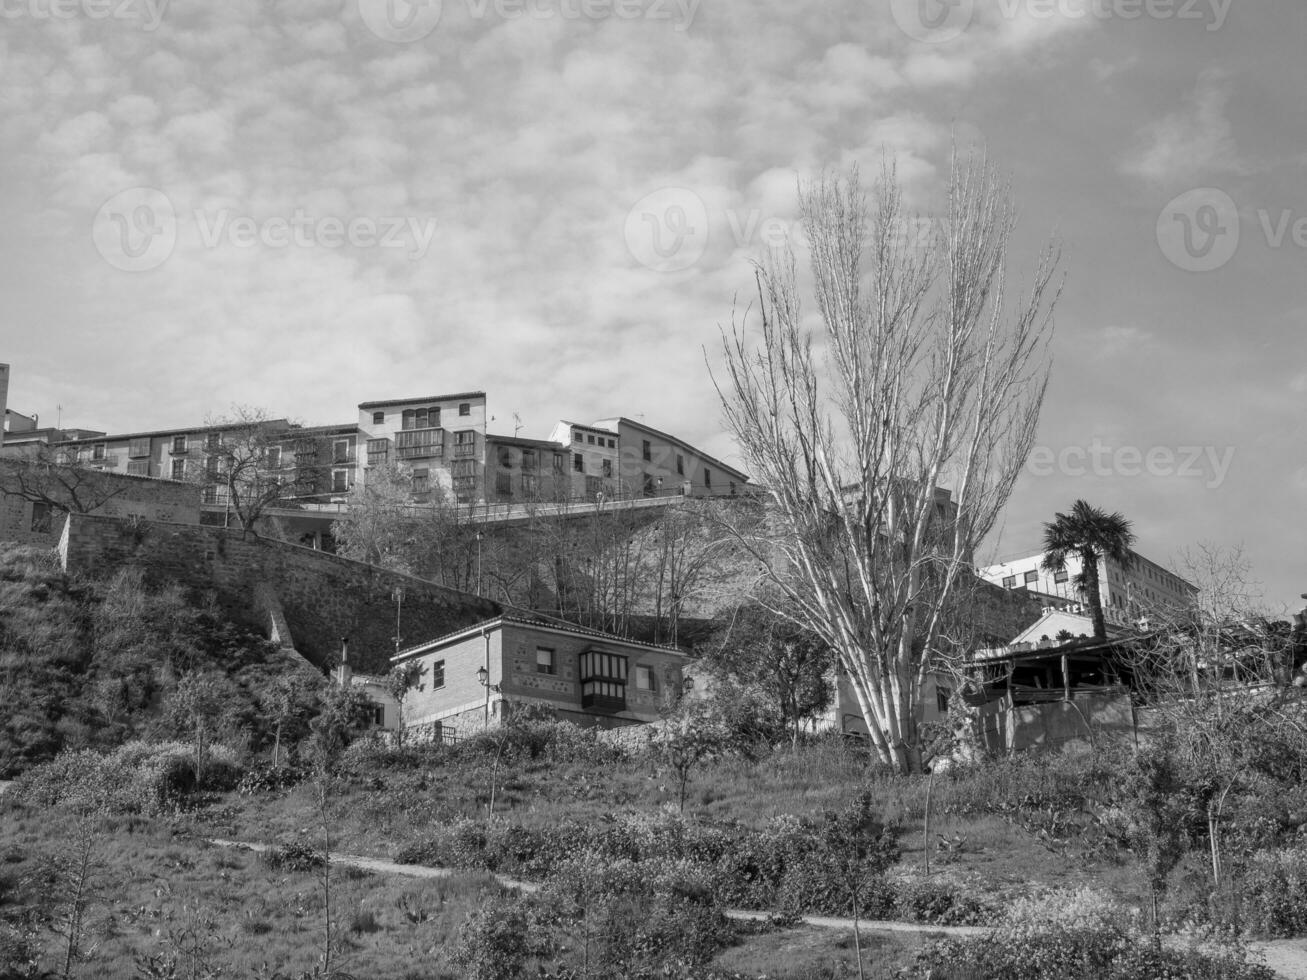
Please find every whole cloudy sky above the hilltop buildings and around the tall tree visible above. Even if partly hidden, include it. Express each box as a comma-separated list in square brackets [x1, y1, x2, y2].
[0, 0, 1307, 608]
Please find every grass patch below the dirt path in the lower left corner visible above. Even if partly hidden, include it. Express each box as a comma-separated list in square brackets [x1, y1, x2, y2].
[0, 808, 502, 980]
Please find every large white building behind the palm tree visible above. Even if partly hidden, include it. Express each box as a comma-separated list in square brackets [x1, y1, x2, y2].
[979, 551, 1199, 625]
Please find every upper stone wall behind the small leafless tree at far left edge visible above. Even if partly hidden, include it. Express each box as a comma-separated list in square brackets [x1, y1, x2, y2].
[0, 457, 200, 547]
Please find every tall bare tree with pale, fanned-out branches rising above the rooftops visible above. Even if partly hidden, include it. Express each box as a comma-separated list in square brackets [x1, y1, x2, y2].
[715, 157, 1059, 771]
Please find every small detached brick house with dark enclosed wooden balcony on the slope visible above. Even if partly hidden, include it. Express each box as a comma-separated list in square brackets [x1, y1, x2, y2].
[391, 613, 691, 737]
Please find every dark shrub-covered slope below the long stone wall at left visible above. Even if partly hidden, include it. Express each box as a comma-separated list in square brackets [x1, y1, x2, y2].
[0, 545, 323, 779]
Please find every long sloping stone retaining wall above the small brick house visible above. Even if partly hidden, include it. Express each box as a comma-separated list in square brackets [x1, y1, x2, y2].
[59, 514, 501, 674]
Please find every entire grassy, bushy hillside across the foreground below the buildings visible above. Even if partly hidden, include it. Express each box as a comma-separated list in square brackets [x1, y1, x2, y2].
[0, 549, 1307, 980]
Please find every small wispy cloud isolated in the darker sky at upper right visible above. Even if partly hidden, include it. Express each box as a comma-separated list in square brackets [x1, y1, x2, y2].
[1120, 71, 1248, 183]
